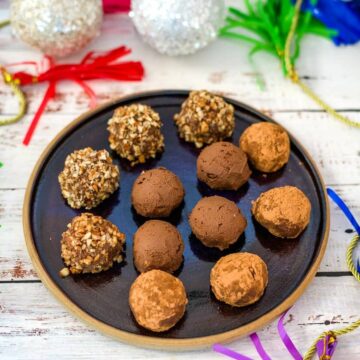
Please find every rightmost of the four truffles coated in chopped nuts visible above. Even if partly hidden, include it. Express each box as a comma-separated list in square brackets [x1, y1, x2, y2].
[174, 90, 235, 148]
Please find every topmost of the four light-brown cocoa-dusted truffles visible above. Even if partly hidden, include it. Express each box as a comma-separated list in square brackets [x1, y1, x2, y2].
[240, 122, 290, 173]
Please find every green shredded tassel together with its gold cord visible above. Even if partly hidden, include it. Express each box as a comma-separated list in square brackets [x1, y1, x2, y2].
[220, 0, 360, 128]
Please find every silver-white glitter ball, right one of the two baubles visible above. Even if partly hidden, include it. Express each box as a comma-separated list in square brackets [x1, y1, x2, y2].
[130, 0, 225, 56]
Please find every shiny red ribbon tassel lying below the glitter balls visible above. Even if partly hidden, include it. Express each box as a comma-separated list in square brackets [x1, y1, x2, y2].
[7, 46, 144, 145]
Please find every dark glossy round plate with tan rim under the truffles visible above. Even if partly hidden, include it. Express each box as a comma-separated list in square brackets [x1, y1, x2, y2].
[23, 91, 329, 349]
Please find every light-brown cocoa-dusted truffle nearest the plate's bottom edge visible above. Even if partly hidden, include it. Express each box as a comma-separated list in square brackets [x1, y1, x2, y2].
[129, 270, 188, 332]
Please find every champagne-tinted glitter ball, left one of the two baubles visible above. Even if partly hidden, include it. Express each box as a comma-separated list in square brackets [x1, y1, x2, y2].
[10, 0, 103, 56]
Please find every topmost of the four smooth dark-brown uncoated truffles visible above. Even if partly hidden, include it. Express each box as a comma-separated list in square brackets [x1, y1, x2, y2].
[197, 141, 251, 190]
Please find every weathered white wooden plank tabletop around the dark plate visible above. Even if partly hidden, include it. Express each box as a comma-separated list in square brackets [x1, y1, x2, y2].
[0, 1, 360, 360]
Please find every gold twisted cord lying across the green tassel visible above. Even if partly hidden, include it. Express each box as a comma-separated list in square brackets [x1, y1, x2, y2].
[284, 0, 360, 128]
